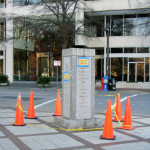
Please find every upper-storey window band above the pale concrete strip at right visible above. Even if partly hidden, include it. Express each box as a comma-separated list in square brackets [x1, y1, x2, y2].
[85, 14, 150, 37]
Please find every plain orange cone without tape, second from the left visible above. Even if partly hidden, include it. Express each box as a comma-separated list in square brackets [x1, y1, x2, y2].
[26, 91, 37, 119]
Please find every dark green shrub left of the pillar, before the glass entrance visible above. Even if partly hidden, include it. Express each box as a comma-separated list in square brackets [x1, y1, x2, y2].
[36, 76, 50, 87]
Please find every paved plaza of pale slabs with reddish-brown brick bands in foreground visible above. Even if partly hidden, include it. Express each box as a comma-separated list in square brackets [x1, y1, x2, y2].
[0, 108, 150, 150]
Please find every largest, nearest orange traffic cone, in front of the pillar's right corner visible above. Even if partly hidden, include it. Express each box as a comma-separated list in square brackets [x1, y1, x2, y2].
[100, 100, 115, 140]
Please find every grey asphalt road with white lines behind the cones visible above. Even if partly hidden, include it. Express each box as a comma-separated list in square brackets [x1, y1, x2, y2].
[0, 83, 150, 115]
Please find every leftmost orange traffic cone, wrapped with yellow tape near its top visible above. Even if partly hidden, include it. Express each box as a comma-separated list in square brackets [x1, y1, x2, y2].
[13, 93, 25, 126]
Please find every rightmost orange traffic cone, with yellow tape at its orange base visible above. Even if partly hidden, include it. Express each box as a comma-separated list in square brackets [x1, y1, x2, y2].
[120, 96, 135, 130]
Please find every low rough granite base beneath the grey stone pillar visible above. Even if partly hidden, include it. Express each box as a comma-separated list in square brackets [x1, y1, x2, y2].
[54, 117, 104, 129]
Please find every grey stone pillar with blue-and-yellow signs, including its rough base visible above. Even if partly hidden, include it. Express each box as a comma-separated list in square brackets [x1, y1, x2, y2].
[54, 48, 102, 128]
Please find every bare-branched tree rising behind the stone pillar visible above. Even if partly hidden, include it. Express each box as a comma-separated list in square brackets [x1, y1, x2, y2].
[14, 0, 83, 49]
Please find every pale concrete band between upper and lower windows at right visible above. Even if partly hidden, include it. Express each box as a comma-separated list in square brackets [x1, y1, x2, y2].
[78, 35, 150, 48]
